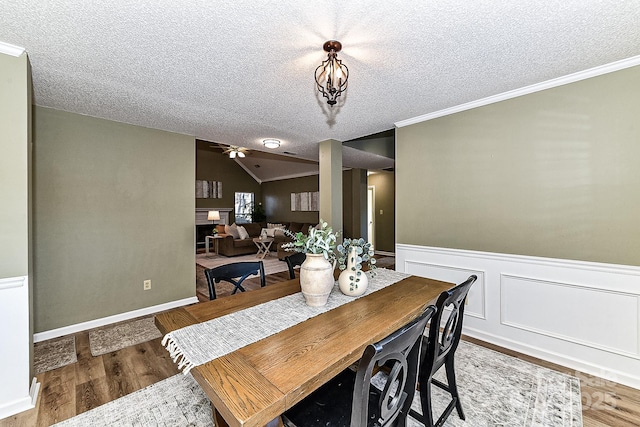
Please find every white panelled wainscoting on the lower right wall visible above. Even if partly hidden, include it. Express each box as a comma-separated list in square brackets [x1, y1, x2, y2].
[396, 244, 640, 389]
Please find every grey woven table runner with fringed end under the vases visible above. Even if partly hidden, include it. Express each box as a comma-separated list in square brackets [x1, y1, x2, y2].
[162, 268, 409, 374]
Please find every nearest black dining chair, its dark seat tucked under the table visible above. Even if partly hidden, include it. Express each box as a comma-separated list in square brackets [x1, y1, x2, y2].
[282, 306, 436, 427]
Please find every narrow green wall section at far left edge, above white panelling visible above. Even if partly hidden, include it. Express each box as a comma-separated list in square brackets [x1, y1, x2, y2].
[0, 54, 31, 278]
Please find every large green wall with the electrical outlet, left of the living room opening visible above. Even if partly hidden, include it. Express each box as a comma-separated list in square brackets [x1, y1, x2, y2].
[34, 107, 195, 332]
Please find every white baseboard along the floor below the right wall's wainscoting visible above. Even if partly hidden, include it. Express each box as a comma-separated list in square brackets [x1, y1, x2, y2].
[462, 326, 640, 390]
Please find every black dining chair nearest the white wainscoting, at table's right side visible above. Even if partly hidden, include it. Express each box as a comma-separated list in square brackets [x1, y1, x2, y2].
[409, 275, 478, 427]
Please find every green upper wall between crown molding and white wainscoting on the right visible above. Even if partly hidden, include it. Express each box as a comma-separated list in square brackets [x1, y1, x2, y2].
[396, 67, 640, 265]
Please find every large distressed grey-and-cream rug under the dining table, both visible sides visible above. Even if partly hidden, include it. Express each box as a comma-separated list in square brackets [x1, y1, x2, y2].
[51, 342, 582, 427]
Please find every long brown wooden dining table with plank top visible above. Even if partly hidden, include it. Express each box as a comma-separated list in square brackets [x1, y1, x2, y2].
[155, 276, 454, 427]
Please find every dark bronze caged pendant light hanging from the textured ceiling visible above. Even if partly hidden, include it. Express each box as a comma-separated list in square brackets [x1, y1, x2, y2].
[315, 40, 349, 107]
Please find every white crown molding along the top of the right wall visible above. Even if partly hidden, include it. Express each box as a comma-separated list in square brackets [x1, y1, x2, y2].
[394, 55, 640, 128]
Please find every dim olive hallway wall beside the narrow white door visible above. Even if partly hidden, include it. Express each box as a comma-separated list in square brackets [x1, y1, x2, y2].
[368, 172, 396, 252]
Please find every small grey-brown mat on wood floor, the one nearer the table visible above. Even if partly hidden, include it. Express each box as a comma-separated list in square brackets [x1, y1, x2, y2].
[89, 316, 162, 356]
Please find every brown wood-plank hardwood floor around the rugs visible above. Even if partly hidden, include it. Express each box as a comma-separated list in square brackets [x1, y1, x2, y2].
[0, 273, 640, 427]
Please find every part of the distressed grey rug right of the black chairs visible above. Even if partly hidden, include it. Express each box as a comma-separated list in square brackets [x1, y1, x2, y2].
[407, 341, 582, 427]
